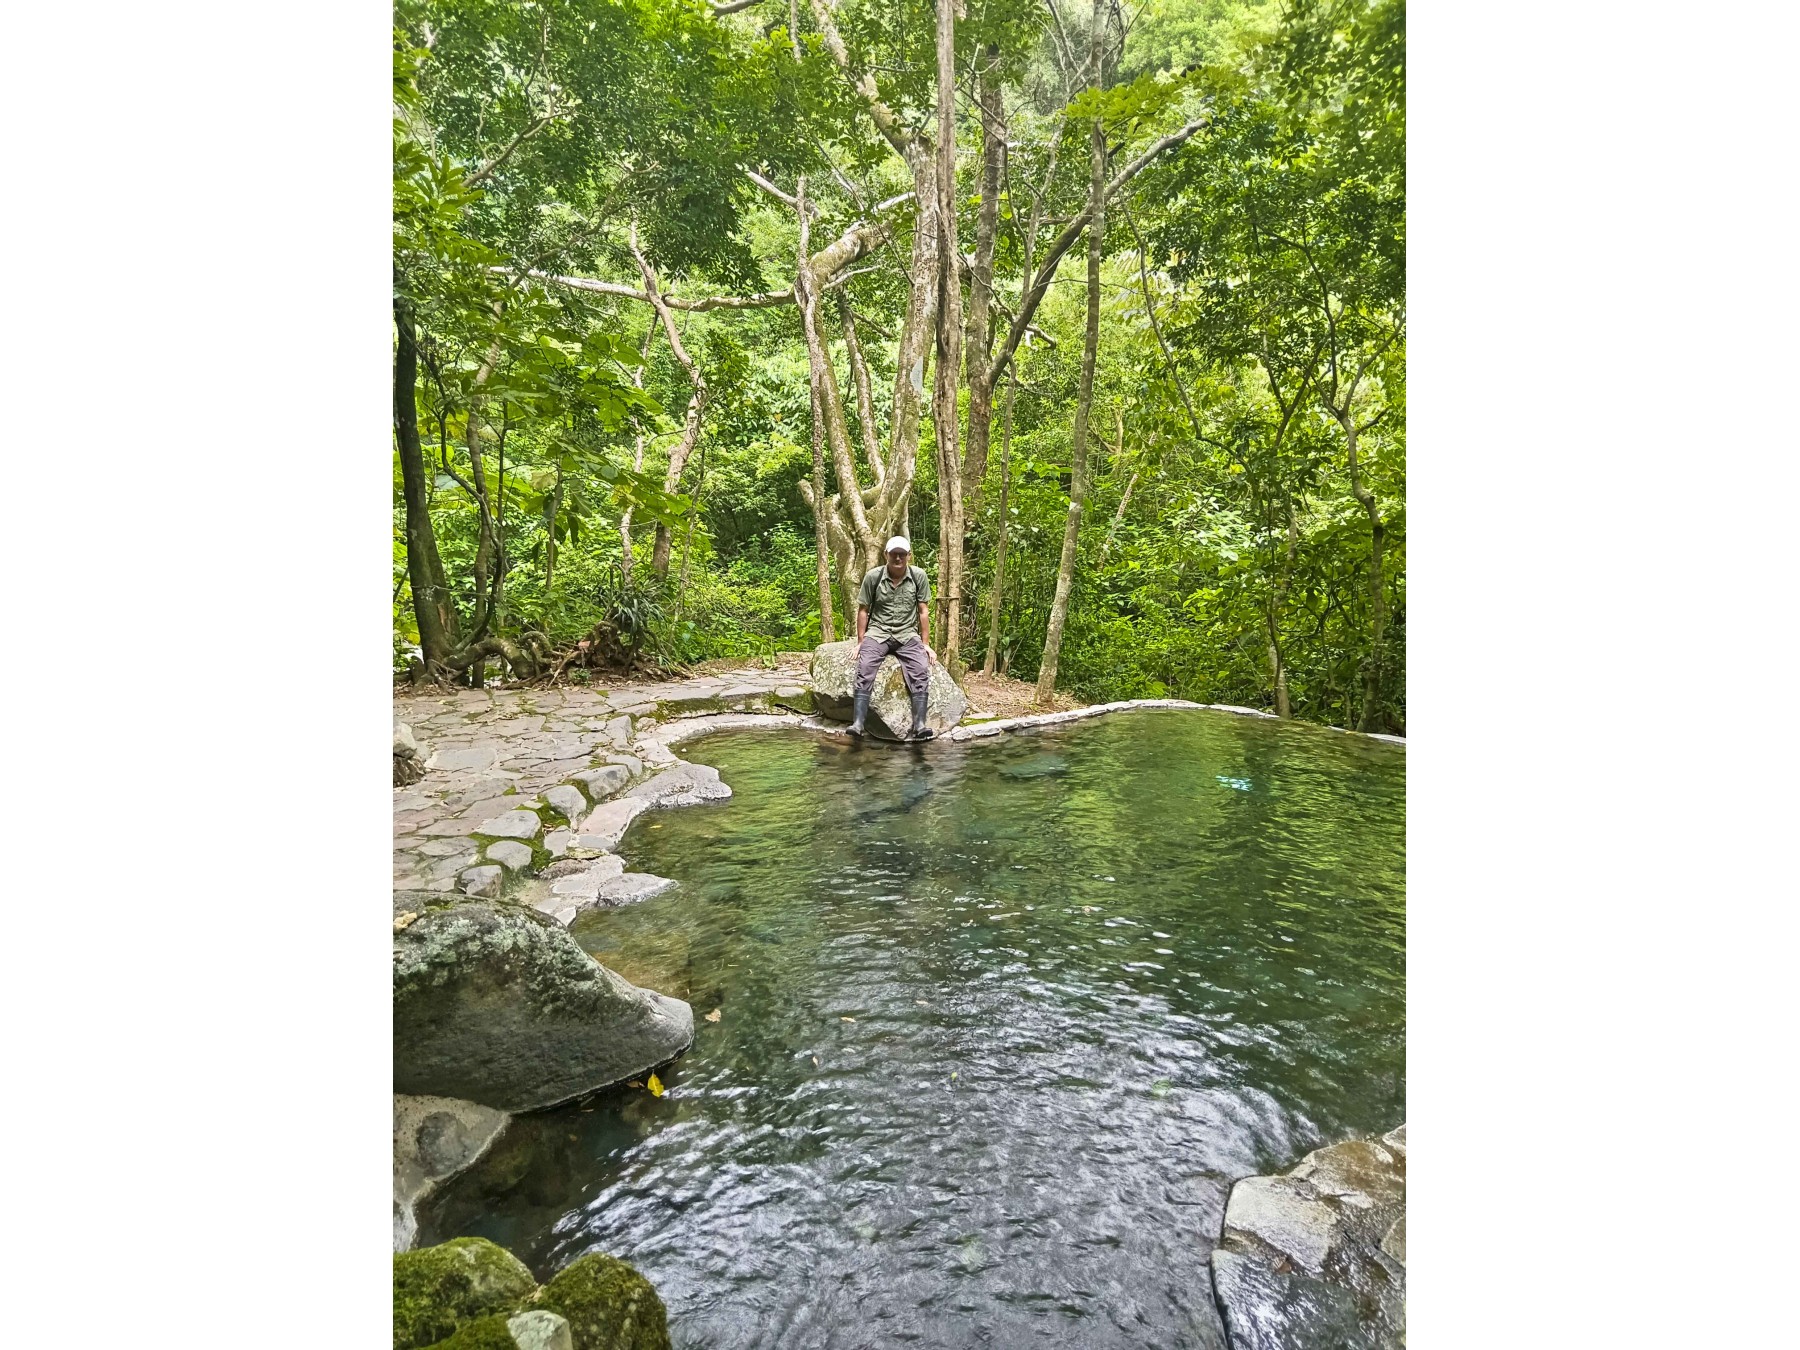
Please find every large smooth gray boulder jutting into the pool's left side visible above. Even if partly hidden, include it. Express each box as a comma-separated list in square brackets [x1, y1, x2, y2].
[394, 900, 693, 1112]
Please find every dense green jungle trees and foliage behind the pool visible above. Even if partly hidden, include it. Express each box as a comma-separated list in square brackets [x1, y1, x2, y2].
[394, 0, 1406, 731]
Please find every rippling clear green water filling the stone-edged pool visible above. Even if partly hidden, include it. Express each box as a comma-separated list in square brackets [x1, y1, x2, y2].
[421, 711, 1406, 1350]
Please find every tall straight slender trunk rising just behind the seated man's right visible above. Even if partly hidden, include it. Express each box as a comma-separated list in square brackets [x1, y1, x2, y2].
[931, 0, 963, 675]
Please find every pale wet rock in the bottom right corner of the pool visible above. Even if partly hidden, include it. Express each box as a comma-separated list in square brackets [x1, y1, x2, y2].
[1211, 1125, 1406, 1350]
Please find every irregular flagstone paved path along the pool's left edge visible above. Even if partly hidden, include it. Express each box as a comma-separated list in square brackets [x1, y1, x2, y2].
[394, 655, 812, 922]
